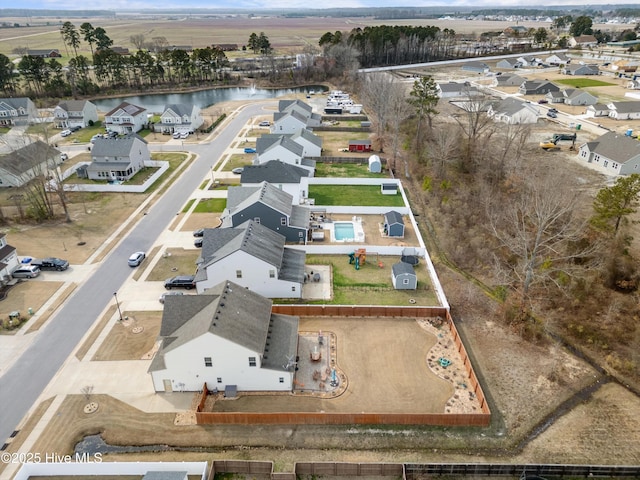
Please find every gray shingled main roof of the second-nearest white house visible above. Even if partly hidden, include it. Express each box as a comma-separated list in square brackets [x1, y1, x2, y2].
[196, 220, 286, 281]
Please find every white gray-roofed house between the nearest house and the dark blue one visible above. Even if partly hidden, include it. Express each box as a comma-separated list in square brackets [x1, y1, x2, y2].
[195, 220, 305, 298]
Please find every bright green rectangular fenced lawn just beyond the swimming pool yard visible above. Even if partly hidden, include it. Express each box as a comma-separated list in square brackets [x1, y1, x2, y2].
[309, 185, 404, 207]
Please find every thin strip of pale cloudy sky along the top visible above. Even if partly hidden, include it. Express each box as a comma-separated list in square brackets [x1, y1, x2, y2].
[15, 0, 638, 11]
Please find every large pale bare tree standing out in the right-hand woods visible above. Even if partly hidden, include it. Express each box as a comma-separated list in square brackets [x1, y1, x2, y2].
[486, 167, 597, 321]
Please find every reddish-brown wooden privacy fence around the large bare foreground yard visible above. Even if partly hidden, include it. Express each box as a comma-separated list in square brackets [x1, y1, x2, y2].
[196, 305, 491, 427]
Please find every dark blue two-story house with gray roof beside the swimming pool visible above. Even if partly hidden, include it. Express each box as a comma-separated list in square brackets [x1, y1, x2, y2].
[220, 182, 311, 243]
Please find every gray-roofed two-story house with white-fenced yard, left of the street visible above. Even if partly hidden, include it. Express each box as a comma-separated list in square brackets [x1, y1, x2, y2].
[83, 135, 151, 181]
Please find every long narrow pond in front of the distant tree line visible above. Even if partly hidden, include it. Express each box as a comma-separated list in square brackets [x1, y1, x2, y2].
[92, 85, 328, 114]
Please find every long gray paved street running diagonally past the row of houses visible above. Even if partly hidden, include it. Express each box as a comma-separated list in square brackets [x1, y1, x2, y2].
[0, 102, 273, 445]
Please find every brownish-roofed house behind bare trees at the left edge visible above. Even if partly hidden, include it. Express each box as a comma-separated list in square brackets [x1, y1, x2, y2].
[0, 140, 62, 187]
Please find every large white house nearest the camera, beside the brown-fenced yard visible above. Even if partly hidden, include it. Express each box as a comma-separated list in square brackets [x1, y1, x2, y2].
[149, 282, 299, 392]
